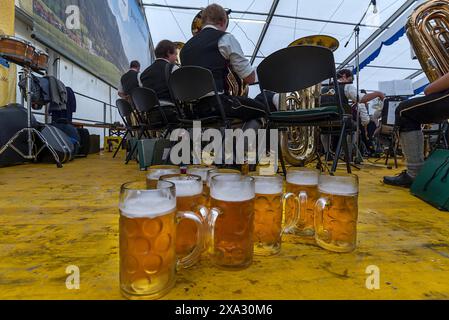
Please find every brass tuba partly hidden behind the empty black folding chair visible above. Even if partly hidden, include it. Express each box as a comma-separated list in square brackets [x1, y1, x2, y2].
[279, 35, 340, 166]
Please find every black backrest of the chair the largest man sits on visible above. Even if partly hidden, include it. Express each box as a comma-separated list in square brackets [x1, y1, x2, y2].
[168, 66, 217, 102]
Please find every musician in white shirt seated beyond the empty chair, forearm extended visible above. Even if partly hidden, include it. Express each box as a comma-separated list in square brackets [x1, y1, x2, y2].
[321, 69, 385, 153]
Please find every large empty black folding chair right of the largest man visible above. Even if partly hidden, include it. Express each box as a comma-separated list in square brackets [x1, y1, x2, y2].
[257, 46, 352, 173]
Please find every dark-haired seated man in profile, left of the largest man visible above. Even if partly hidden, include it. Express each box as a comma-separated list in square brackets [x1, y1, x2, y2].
[140, 40, 178, 103]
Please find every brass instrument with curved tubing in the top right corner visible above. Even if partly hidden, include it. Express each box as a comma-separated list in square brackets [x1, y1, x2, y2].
[406, 0, 449, 82]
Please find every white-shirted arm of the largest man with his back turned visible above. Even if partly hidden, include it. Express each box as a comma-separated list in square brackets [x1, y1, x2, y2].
[218, 33, 256, 84]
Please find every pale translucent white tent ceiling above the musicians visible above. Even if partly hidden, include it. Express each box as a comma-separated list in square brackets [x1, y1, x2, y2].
[143, 0, 421, 90]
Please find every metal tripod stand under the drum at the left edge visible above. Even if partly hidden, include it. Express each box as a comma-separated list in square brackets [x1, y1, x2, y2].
[0, 62, 62, 168]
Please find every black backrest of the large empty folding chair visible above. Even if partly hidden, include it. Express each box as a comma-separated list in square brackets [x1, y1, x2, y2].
[257, 46, 337, 93]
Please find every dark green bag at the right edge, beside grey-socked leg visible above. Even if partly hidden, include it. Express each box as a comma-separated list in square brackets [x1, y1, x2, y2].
[410, 150, 449, 211]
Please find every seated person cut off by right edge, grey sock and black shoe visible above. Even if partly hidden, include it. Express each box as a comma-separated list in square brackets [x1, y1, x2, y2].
[384, 74, 449, 188]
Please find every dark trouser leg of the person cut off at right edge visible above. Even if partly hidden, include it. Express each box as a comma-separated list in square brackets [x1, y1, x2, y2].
[396, 90, 449, 132]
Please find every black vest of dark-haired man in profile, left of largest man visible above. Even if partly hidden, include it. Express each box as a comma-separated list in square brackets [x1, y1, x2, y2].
[140, 59, 173, 100]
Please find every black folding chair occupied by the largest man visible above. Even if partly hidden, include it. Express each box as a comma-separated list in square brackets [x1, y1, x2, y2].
[168, 66, 231, 128]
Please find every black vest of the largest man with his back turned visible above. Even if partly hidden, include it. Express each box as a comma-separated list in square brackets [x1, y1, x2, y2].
[181, 28, 229, 92]
